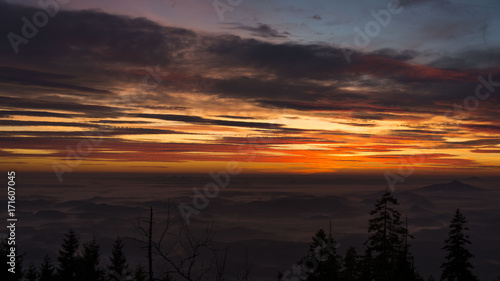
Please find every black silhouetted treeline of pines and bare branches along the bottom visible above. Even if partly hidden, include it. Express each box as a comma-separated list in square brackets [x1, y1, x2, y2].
[0, 192, 479, 281]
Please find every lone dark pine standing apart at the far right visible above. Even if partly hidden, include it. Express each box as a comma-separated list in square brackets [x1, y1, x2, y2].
[441, 209, 478, 281]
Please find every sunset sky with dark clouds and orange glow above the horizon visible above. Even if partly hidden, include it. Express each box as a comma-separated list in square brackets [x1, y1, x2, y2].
[0, 0, 500, 175]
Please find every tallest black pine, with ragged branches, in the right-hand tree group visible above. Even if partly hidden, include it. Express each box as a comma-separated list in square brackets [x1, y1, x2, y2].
[364, 192, 418, 281]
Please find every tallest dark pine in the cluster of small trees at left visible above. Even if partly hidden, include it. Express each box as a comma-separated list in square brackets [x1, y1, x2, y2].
[57, 229, 80, 281]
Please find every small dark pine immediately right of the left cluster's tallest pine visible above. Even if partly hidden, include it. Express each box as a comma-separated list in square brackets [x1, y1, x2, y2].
[77, 239, 104, 281]
